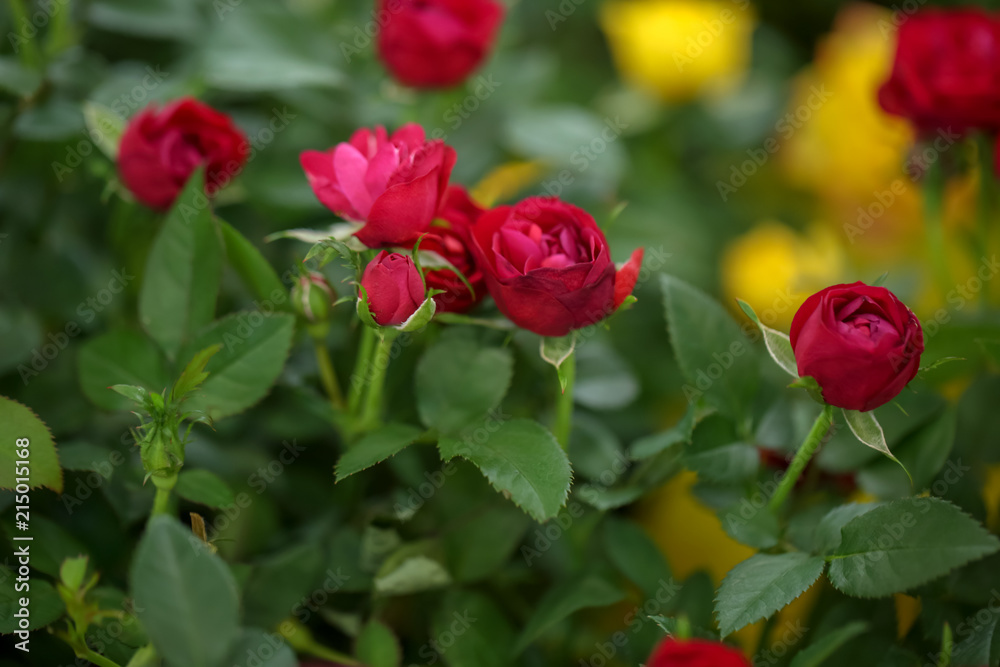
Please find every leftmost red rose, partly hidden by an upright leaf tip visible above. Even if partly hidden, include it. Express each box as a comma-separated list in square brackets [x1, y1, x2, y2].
[118, 97, 250, 210]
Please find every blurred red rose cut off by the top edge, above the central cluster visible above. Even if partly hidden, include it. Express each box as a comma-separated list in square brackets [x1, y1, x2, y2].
[378, 0, 504, 88]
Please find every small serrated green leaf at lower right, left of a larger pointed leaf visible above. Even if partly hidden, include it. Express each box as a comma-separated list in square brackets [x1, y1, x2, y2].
[715, 552, 826, 637]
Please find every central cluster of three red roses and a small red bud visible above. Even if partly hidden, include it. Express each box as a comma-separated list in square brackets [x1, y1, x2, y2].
[302, 124, 642, 336]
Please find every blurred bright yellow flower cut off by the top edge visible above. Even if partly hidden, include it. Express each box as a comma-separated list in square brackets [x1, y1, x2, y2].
[600, 0, 756, 102]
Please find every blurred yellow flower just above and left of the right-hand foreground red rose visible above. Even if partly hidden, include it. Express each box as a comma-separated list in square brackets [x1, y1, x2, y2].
[722, 222, 844, 331]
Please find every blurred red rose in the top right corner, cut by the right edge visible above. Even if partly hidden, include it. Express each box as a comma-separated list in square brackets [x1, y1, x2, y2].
[879, 10, 1000, 131]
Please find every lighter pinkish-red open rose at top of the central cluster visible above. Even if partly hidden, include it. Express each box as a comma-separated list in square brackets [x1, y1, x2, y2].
[300, 123, 455, 248]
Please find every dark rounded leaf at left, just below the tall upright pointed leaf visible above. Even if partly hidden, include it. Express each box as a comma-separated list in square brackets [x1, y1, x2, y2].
[77, 330, 170, 410]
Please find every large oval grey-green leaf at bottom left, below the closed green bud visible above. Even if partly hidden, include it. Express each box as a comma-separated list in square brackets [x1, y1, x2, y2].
[131, 516, 239, 667]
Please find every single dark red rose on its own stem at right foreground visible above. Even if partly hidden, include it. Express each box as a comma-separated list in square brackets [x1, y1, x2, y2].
[791, 282, 924, 411]
